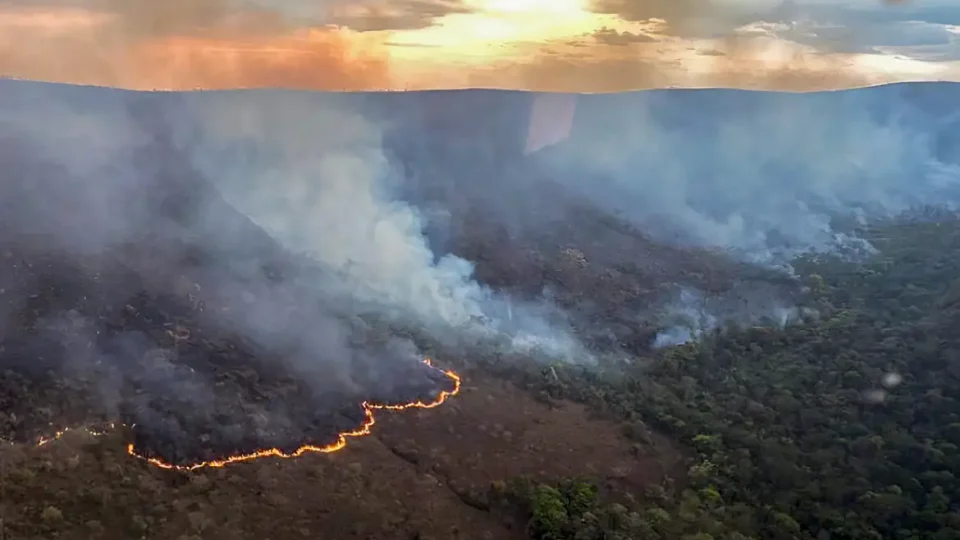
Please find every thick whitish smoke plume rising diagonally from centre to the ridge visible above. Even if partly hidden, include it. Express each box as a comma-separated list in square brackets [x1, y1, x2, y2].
[176, 92, 588, 360]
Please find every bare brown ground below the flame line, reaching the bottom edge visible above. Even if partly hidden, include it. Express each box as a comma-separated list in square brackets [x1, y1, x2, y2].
[0, 368, 680, 540]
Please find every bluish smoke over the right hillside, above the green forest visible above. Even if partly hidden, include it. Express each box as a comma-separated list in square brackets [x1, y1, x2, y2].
[352, 84, 960, 350]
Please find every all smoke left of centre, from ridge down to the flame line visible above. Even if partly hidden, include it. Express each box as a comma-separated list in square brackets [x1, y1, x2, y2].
[0, 81, 592, 461]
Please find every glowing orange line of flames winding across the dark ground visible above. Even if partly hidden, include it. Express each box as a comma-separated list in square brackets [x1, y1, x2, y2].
[29, 358, 461, 471]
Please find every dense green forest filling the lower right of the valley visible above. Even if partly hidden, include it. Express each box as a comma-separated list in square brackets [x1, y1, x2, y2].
[484, 213, 960, 540]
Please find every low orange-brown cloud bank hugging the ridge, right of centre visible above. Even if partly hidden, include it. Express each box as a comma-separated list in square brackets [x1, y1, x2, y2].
[470, 30, 894, 92]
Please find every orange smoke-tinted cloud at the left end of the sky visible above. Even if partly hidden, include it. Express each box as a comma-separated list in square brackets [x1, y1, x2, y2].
[0, 0, 390, 90]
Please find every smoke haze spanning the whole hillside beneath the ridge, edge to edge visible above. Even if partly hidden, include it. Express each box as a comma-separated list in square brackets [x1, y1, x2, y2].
[0, 82, 960, 414]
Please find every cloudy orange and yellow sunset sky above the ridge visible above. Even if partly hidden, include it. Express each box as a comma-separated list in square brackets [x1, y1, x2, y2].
[0, 0, 960, 92]
